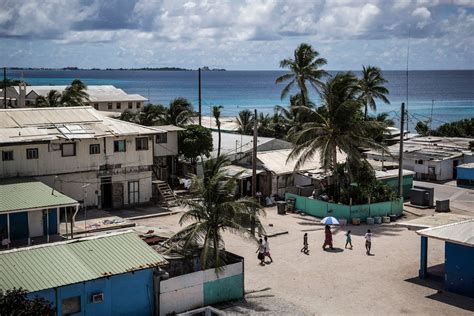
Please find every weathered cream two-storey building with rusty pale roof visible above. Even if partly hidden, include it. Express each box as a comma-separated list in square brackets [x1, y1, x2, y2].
[0, 107, 179, 208]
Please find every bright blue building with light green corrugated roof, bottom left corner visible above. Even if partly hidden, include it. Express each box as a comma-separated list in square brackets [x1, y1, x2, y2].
[0, 231, 167, 315]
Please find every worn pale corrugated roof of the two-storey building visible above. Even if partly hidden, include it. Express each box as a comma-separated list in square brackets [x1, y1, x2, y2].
[0, 107, 164, 143]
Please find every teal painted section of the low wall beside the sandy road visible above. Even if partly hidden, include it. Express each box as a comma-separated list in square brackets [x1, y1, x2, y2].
[203, 274, 244, 306]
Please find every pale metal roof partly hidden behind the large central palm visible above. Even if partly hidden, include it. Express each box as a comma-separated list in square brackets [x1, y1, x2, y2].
[257, 149, 346, 174]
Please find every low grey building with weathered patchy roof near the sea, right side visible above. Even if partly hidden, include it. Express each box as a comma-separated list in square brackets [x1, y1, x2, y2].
[366, 137, 472, 181]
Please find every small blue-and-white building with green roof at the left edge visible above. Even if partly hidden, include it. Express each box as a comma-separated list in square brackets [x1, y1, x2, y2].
[0, 178, 79, 247]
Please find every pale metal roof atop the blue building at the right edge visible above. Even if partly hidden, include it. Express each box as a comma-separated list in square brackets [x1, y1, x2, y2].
[417, 219, 474, 247]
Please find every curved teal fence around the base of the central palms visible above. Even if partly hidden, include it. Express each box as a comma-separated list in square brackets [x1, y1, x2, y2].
[285, 193, 403, 221]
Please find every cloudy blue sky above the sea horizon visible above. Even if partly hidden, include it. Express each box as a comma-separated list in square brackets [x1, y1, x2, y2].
[0, 0, 474, 70]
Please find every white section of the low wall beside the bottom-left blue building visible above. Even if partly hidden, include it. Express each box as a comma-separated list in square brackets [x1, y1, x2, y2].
[160, 262, 243, 316]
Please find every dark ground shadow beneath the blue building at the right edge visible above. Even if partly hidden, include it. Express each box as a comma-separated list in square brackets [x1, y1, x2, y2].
[405, 264, 474, 312]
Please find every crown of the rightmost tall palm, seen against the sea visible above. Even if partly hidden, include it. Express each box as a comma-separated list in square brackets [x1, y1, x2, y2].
[359, 66, 390, 119]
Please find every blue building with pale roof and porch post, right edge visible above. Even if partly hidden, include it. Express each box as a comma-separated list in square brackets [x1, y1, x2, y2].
[417, 219, 474, 297]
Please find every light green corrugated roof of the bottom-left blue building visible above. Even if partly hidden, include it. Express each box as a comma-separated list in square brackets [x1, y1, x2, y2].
[0, 231, 167, 292]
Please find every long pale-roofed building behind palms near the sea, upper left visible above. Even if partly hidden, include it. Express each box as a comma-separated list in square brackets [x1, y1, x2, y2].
[1, 85, 148, 113]
